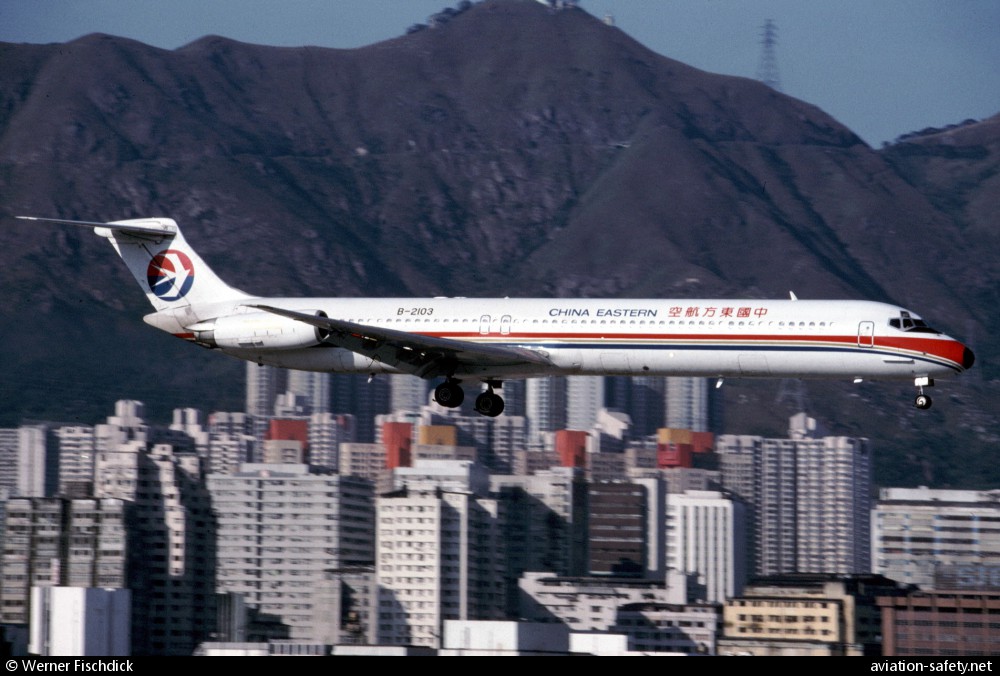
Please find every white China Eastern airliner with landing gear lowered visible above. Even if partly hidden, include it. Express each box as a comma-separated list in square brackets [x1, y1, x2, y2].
[11, 216, 975, 417]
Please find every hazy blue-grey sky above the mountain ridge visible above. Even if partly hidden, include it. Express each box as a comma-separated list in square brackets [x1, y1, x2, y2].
[0, 0, 1000, 147]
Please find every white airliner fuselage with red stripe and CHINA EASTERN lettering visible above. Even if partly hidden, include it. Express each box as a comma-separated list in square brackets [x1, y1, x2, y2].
[168, 298, 971, 386]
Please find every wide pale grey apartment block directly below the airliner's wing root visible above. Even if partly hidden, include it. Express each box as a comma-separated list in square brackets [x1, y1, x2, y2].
[208, 464, 374, 642]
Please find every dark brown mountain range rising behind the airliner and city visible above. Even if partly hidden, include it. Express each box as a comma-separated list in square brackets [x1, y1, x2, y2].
[0, 0, 1000, 486]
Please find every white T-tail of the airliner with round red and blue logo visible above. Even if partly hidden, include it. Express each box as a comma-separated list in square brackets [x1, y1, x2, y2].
[18, 216, 250, 312]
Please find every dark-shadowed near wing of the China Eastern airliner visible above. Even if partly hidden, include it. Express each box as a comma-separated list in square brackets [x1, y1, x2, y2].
[248, 305, 552, 378]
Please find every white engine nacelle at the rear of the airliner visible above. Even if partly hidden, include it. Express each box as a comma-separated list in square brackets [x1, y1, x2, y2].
[195, 310, 328, 350]
